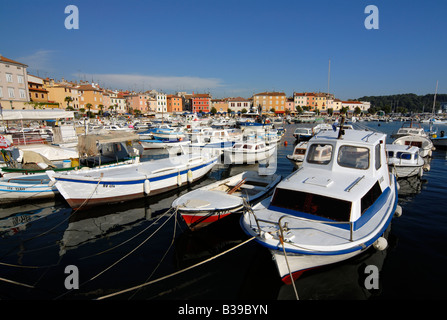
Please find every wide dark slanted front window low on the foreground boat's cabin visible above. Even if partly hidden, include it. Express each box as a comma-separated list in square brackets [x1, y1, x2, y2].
[271, 188, 351, 222]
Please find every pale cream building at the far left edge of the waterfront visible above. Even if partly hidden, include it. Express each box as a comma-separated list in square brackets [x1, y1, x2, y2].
[0, 54, 32, 109]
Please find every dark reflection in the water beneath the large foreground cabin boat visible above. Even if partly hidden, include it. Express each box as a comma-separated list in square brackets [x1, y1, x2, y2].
[277, 228, 394, 300]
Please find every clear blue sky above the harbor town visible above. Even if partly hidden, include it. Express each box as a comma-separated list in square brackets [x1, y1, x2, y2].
[0, 0, 447, 99]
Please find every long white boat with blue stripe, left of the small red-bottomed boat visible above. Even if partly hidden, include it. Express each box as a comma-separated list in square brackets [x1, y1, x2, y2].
[47, 154, 217, 209]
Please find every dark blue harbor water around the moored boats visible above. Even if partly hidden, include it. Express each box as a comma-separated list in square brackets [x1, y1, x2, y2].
[0, 122, 447, 301]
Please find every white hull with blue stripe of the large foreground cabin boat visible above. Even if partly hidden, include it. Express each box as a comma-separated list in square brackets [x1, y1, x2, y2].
[240, 177, 398, 283]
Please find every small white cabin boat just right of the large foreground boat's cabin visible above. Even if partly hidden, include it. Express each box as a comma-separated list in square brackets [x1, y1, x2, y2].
[386, 144, 430, 178]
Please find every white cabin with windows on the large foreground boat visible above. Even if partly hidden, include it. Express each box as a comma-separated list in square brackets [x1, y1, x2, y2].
[270, 130, 390, 225]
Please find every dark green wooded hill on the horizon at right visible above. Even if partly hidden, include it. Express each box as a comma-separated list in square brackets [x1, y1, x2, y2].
[357, 93, 447, 113]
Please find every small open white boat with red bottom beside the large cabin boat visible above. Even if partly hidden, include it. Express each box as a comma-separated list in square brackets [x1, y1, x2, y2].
[172, 171, 281, 230]
